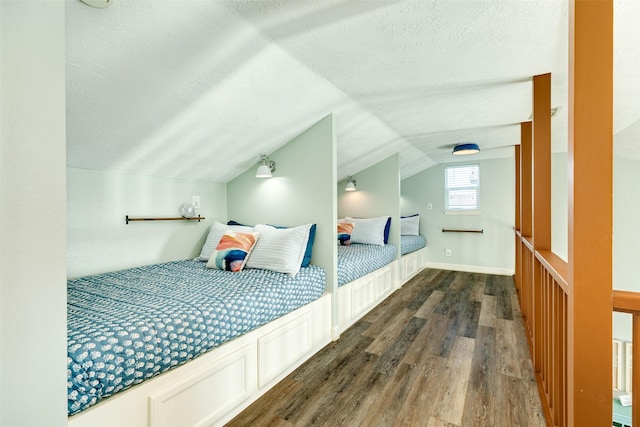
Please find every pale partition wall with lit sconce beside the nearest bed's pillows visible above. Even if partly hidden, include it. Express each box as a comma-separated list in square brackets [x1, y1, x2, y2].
[227, 115, 336, 292]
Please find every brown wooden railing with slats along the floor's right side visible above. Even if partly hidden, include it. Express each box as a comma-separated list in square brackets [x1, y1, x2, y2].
[515, 233, 568, 426]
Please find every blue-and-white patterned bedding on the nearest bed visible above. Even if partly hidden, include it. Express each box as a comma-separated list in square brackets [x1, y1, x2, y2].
[67, 260, 325, 414]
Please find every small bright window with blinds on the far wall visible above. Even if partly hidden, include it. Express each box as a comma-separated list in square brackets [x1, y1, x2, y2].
[444, 164, 480, 212]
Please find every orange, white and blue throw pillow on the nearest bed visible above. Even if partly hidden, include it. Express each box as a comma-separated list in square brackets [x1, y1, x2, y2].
[207, 230, 260, 271]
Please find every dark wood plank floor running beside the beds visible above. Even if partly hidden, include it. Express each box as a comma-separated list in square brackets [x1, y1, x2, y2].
[228, 270, 545, 427]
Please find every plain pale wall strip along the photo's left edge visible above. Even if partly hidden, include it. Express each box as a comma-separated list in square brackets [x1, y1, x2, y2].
[0, 0, 67, 427]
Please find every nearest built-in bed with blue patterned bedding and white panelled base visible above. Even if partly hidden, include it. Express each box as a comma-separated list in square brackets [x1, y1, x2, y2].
[67, 223, 331, 427]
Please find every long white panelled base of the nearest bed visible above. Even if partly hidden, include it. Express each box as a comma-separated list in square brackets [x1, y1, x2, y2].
[68, 293, 331, 427]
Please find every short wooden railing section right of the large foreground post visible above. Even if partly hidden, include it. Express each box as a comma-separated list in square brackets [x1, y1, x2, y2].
[613, 290, 640, 426]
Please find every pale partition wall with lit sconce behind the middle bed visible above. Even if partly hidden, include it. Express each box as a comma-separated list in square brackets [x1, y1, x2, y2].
[337, 154, 400, 252]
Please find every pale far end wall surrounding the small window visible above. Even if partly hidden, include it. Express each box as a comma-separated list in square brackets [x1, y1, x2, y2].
[400, 157, 515, 274]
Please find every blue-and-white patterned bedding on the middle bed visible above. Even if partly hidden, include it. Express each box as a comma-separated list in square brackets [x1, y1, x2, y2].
[338, 243, 397, 286]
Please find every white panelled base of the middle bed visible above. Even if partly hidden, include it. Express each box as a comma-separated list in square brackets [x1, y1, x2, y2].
[337, 260, 399, 334]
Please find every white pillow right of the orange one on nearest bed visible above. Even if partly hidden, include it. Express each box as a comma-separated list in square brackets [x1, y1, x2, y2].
[245, 224, 311, 276]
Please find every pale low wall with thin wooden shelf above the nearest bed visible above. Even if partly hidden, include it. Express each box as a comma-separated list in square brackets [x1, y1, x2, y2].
[67, 168, 227, 278]
